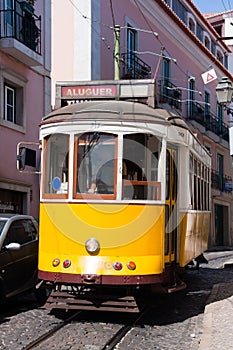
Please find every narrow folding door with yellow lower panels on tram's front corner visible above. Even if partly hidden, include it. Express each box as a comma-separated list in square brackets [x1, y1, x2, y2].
[164, 148, 177, 263]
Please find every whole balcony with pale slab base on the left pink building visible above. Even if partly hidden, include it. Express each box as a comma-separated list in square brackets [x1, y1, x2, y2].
[0, 0, 43, 66]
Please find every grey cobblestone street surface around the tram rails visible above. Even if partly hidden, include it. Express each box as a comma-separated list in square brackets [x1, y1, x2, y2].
[0, 251, 233, 350]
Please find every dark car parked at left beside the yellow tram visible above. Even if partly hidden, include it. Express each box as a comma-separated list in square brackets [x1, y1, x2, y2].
[0, 214, 38, 300]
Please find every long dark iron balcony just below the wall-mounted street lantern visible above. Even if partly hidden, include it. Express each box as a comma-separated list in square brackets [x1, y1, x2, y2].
[189, 102, 229, 142]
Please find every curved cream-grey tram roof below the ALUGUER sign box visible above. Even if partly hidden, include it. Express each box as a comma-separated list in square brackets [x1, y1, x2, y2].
[41, 100, 189, 129]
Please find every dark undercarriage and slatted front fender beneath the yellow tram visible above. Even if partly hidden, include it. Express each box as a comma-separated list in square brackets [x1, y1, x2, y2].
[38, 265, 186, 312]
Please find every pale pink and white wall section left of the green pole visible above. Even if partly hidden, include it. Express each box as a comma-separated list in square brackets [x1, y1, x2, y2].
[52, 0, 101, 105]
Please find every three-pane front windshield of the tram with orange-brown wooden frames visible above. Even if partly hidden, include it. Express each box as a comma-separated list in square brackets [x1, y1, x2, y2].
[43, 132, 162, 200]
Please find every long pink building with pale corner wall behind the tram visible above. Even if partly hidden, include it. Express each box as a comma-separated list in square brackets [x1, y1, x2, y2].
[52, 0, 233, 246]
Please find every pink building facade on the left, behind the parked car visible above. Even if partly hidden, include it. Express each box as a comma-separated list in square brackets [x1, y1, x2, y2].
[0, 0, 51, 218]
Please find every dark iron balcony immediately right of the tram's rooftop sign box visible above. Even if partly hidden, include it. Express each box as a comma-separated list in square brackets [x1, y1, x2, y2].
[158, 80, 182, 111]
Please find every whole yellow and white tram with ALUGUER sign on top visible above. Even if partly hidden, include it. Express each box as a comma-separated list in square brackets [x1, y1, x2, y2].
[36, 81, 211, 309]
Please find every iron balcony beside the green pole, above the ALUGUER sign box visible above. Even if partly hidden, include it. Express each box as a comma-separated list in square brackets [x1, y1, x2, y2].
[120, 52, 151, 79]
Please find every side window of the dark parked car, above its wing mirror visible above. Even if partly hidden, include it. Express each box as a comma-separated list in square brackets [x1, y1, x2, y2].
[4, 219, 37, 245]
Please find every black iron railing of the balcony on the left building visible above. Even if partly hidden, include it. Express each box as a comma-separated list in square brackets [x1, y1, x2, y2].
[0, 0, 41, 54]
